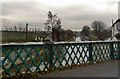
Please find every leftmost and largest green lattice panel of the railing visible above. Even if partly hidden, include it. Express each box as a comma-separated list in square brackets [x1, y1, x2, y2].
[2, 46, 49, 76]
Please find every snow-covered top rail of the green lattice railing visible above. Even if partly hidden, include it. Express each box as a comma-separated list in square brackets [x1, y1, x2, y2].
[0, 41, 120, 46]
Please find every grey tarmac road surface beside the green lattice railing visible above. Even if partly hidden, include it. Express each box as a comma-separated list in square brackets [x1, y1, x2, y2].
[40, 60, 119, 77]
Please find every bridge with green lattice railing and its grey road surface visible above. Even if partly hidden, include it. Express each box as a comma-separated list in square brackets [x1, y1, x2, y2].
[0, 41, 120, 78]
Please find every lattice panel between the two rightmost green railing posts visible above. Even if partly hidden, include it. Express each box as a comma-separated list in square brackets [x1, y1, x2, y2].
[92, 43, 111, 61]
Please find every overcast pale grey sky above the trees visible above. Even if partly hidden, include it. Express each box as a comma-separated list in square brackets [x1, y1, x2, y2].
[0, 0, 119, 30]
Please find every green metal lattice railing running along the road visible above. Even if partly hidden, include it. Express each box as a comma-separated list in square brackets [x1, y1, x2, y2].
[0, 42, 120, 77]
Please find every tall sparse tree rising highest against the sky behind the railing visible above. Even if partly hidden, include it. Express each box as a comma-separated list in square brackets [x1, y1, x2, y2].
[44, 11, 62, 41]
